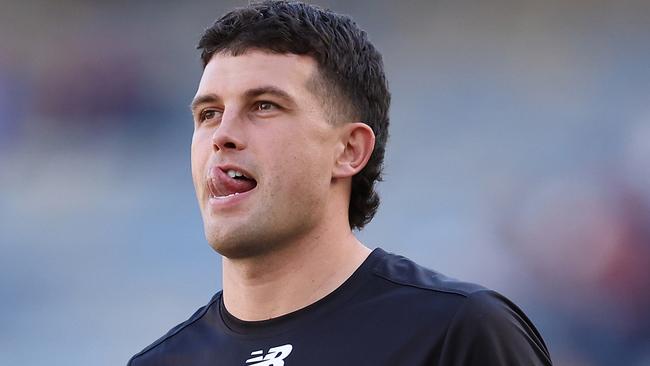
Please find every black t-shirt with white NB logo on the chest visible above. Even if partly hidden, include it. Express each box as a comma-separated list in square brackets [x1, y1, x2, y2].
[128, 249, 551, 366]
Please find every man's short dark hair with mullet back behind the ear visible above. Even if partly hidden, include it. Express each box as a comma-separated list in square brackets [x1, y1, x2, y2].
[198, 1, 390, 229]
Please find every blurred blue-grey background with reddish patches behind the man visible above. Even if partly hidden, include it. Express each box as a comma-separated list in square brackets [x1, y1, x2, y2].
[0, 0, 650, 366]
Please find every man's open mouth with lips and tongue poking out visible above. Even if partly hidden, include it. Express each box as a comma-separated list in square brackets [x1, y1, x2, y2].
[207, 166, 257, 198]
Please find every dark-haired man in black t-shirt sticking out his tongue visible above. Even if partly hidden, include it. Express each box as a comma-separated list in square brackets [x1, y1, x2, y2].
[129, 1, 551, 366]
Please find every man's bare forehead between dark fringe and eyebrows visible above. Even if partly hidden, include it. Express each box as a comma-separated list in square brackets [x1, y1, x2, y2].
[196, 50, 316, 98]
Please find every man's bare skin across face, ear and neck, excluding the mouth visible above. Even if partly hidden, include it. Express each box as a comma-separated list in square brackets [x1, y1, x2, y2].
[191, 50, 374, 320]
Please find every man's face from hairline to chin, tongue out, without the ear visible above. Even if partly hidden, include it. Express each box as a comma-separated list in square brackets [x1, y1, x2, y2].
[192, 50, 339, 258]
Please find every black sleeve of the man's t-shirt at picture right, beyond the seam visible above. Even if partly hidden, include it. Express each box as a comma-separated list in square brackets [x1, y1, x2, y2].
[438, 290, 552, 366]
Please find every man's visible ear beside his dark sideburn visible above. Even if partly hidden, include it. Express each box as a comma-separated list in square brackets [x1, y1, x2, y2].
[332, 122, 375, 178]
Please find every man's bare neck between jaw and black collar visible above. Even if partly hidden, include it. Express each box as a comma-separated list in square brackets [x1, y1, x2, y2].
[223, 225, 370, 321]
